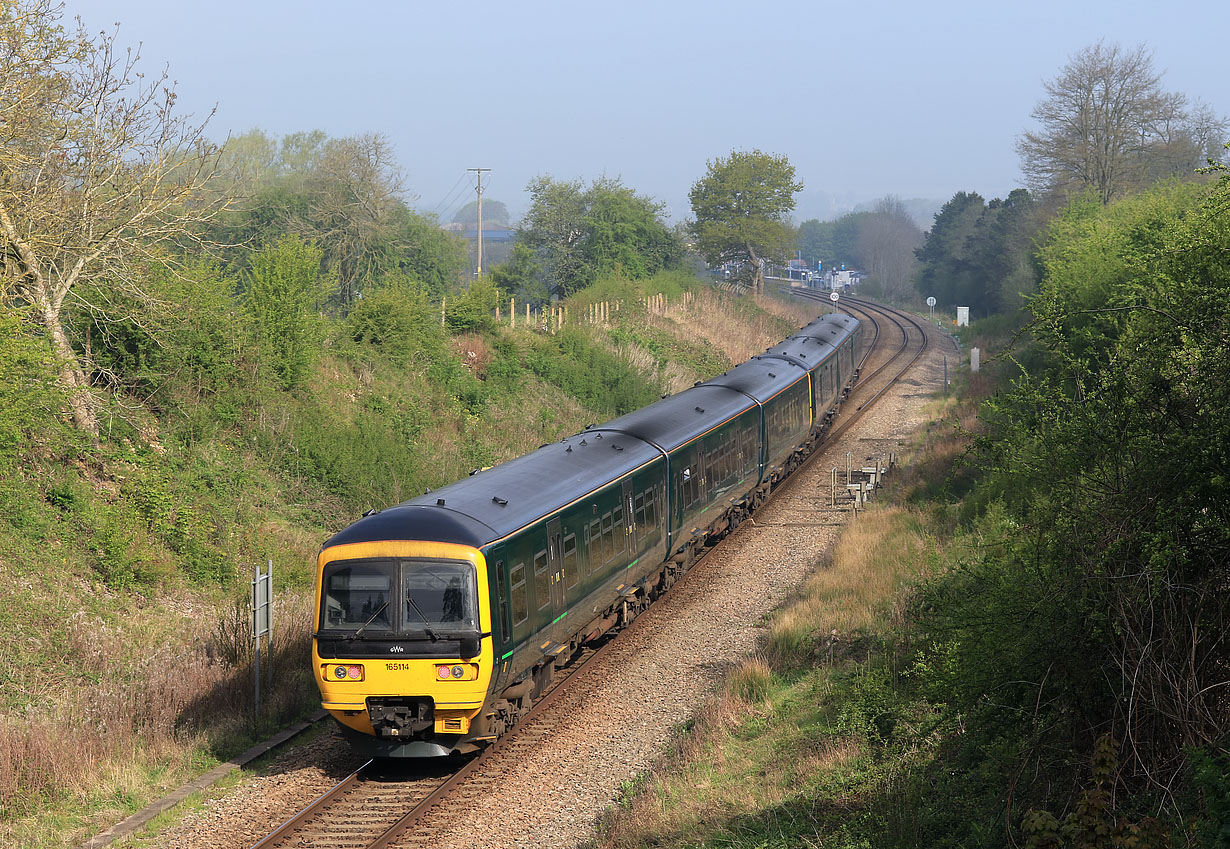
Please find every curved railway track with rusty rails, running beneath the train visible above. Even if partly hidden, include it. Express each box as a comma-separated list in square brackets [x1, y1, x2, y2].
[253, 289, 929, 849]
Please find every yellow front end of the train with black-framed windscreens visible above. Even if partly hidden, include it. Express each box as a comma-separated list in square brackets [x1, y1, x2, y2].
[312, 531, 493, 758]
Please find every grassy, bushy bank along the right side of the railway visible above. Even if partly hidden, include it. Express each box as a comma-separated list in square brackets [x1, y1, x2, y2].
[597, 168, 1230, 849]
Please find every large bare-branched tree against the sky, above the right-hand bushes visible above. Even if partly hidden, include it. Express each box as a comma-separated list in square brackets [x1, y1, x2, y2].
[1017, 42, 1226, 203]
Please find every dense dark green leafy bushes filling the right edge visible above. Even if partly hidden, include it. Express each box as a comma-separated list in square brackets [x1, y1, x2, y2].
[920, 178, 1230, 811]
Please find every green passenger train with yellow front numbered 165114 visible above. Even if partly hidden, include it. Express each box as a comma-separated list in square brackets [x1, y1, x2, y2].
[311, 308, 862, 758]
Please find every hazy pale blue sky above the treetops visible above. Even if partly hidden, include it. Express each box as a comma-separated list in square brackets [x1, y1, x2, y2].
[66, 0, 1230, 220]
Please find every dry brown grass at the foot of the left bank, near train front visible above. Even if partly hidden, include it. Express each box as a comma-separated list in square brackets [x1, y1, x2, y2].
[0, 592, 312, 845]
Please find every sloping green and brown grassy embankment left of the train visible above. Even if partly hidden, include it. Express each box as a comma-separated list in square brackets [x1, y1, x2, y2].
[0, 276, 809, 847]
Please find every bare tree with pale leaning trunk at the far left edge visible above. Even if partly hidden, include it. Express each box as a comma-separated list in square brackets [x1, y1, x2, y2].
[0, 0, 228, 440]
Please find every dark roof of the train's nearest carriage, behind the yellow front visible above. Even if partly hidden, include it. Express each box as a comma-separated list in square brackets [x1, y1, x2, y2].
[325, 431, 662, 548]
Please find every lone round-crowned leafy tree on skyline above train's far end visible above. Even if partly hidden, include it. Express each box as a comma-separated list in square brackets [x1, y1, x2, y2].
[689, 150, 803, 292]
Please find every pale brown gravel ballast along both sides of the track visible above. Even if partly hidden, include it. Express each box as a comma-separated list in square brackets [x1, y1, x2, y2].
[141, 314, 954, 849]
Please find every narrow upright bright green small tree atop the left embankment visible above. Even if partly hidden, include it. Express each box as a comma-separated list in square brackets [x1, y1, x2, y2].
[246, 236, 323, 389]
